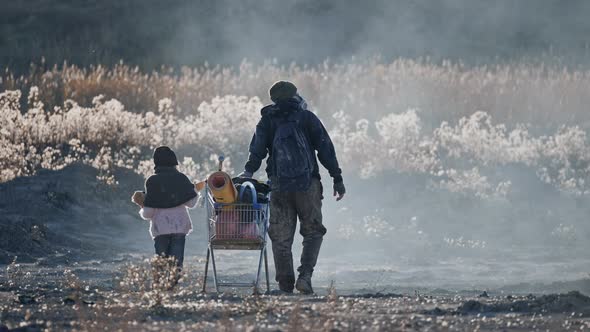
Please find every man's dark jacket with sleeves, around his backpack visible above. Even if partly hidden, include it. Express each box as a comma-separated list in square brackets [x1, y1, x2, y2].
[244, 96, 342, 191]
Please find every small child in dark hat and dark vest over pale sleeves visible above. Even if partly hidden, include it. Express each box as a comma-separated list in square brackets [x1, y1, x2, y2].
[131, 146, 199, 270]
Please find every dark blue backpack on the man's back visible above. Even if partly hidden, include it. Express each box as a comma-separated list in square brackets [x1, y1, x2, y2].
[271, 113, 313, 191]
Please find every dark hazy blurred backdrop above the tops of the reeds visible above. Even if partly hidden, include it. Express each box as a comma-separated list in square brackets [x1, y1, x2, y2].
[0, 0, 590, 71]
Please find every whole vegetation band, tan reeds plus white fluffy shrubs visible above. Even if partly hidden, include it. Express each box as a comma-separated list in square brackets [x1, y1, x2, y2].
[0, 59, 590, 197]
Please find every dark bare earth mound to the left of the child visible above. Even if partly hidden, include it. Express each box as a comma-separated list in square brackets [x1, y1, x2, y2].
[0, 164, 150, 265]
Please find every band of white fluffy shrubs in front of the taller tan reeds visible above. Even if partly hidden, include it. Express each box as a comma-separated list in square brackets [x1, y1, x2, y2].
[0, 87, 590, 199]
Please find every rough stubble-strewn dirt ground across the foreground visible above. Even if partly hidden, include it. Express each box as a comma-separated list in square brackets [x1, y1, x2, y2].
[0, 256, 590, 331]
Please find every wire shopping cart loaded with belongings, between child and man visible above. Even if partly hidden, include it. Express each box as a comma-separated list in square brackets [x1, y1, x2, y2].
[203, 182, 270, 293]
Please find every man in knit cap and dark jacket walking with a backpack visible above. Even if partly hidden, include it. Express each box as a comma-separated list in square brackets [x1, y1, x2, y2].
[240, 81, 346, 294]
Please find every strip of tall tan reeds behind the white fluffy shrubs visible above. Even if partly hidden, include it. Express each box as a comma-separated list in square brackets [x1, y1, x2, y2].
[0, 59, 590, 126]
